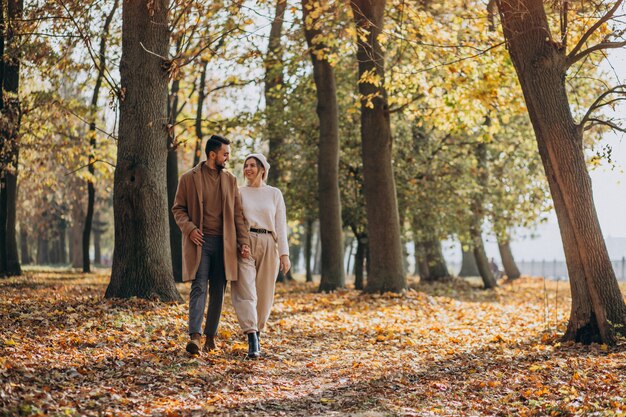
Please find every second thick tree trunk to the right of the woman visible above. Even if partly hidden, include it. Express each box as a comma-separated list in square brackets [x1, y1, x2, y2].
[350, 0, 406, 292]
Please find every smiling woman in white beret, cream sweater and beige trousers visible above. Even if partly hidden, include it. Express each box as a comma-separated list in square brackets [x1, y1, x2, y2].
[231, 153, 291, 358]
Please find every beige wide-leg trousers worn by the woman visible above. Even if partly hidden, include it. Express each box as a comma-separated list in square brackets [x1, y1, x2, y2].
[230, 232, 280, 333]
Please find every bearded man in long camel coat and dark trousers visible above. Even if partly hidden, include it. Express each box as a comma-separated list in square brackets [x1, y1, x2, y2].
[172, 135, 250, 355]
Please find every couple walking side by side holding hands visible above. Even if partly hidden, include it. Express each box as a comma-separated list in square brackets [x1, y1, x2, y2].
[172, 135, 290, 358]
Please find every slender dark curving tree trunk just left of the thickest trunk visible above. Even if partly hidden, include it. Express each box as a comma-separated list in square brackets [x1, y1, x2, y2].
[83, 0, 119, 272]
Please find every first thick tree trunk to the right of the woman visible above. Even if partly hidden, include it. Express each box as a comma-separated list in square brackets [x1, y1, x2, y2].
[302, 0, 345, 291]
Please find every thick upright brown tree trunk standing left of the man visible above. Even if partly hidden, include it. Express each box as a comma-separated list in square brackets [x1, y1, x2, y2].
[105, 0, 182, 301]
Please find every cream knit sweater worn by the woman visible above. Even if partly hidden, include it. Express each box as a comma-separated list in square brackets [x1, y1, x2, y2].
[239, 184, 289, 256]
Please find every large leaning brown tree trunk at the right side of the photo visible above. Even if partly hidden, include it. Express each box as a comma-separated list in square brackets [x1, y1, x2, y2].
[498, 0, 626, 344]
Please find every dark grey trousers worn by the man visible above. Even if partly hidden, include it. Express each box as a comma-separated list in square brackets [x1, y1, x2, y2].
[189, 236, 226, 336]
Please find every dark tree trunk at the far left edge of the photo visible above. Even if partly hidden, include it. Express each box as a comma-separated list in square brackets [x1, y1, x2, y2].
[0, 0, 24, 275]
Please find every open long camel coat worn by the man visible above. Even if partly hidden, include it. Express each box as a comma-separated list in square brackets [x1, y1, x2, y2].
[172, 162, 250, 282]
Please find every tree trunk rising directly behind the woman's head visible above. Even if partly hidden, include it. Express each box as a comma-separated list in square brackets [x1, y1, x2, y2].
[264, 0, 287, 186]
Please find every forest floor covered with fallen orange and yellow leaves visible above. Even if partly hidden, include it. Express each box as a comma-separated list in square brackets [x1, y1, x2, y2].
[0, 271, 626, 417]
